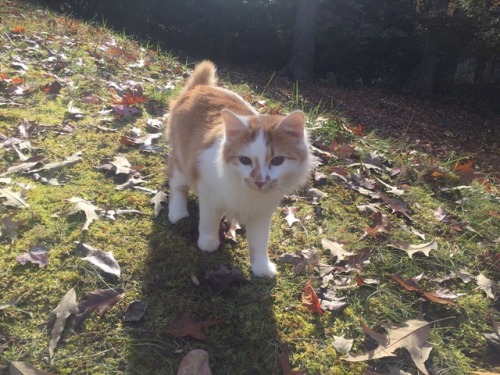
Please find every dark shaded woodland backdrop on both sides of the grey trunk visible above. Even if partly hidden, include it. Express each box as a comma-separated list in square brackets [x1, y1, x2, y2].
[39, 0, 500, 101]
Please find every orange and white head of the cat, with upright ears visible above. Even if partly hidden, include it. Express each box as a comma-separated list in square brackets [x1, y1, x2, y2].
[222, 109, 311, 193]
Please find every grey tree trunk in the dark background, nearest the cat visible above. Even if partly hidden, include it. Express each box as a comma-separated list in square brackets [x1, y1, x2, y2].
[286, 0, 320, 81]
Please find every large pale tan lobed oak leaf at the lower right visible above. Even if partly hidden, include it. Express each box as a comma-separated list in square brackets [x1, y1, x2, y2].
[342, 319, 433, 375]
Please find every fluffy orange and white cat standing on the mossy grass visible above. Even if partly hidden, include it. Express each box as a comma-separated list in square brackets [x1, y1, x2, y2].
[166, 60, 313, 277]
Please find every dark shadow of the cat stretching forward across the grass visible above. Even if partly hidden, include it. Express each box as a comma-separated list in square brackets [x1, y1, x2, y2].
[130, 199, 280, 375]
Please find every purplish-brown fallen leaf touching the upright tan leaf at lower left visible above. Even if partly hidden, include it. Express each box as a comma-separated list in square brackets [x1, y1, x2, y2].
[75, 288, 125, 327]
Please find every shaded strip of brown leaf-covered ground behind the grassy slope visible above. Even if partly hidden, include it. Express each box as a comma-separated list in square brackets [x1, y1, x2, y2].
[219, 66, 500, 181]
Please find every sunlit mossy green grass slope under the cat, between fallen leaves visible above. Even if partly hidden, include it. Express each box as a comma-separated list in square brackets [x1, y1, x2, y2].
[0, 1, 500, 375]
